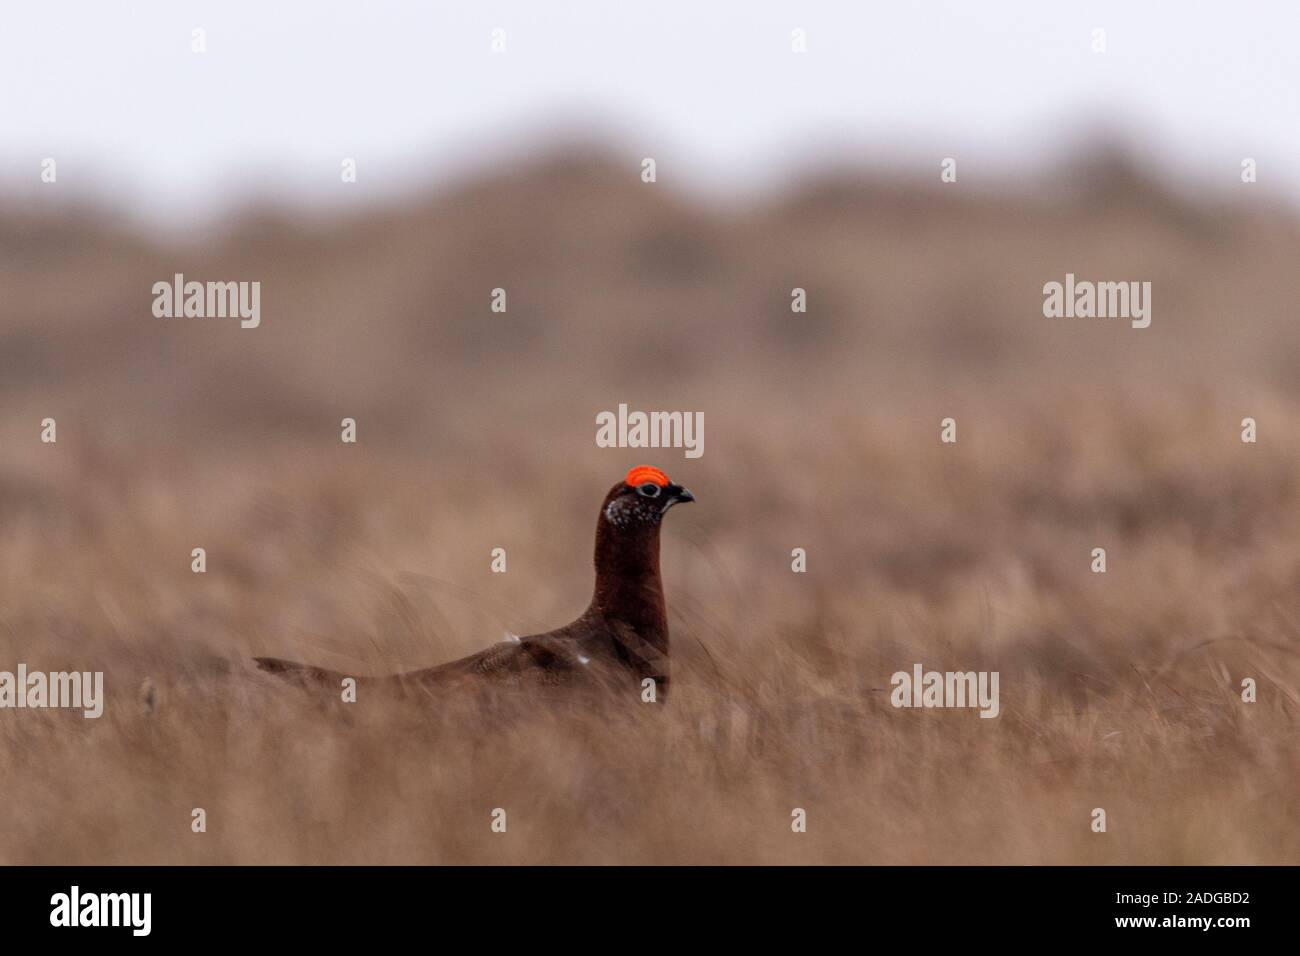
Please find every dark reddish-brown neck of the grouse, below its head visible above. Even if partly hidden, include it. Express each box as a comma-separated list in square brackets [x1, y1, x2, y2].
[592, 518, 668, 652]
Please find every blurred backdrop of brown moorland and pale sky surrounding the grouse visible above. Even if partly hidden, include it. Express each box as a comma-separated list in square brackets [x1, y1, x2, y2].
[0, 3, 1300, 862]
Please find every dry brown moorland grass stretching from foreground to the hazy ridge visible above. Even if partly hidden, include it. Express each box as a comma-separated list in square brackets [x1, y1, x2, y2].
[0, 147, 1300, 864]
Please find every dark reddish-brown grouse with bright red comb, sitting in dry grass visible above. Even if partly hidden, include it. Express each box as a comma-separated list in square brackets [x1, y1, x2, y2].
[254, 464, 696, 701]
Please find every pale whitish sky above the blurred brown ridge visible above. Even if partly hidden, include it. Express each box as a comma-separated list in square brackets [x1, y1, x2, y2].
[0, 0, 1300, 217]
